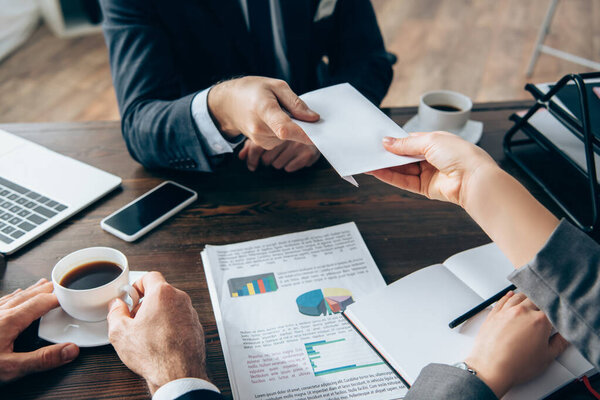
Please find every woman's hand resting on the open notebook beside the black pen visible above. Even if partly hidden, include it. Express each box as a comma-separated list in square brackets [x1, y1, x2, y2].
[465, 292, 569, 398]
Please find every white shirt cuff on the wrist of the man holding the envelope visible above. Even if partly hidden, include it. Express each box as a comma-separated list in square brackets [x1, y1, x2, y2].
[192, 88, 244, 156]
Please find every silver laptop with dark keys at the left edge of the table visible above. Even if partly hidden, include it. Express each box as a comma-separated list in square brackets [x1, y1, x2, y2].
[0, 130, 121, 254]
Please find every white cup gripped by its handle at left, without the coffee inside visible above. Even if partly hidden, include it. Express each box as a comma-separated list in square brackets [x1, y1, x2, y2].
[52, 247, 139, 322]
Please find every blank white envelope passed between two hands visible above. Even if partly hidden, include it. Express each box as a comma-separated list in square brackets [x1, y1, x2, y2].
[295, 83, 422, 186]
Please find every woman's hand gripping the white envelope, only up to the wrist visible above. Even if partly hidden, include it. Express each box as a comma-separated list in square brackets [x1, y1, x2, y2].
[370, 132, 499, 206]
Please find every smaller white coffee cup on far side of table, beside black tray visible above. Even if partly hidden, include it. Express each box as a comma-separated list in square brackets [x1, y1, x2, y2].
[419, 90, 473, 133]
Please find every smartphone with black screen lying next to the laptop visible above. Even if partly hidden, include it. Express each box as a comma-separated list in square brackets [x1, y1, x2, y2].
[100, 181, 198, 242]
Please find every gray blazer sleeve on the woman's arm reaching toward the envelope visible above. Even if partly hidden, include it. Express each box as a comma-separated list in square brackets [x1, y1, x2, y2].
[508, 220, 600, 367]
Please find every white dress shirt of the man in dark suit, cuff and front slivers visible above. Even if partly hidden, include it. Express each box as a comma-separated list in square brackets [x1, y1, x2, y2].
[192, 0, 290, 157]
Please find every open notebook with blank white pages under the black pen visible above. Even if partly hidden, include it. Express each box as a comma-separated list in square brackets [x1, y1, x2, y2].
[344, 243, 594, 399]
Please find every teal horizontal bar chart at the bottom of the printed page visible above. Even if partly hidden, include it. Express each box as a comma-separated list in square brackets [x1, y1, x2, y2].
[304, 338, 383, 376]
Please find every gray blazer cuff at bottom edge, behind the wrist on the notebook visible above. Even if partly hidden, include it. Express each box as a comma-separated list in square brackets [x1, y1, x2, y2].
[404, 364, 498, 400]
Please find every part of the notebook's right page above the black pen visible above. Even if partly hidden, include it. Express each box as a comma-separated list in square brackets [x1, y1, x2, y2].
[444, 243, 515, 298]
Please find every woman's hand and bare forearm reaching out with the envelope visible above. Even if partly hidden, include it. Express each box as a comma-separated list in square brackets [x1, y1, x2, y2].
[370, 132, 558, 268]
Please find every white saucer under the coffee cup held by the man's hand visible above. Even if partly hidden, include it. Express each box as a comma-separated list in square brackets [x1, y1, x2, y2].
[38, 271, 146, 347]
